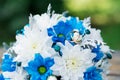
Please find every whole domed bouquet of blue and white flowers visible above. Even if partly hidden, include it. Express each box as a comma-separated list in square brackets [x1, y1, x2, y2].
[0, 7, 112, 80]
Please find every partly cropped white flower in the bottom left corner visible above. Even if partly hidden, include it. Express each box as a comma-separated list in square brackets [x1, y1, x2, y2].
[3, 68, 28, 80]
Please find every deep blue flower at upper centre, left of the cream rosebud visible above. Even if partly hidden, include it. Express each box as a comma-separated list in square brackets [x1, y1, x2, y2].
[48, 21, 72, 44]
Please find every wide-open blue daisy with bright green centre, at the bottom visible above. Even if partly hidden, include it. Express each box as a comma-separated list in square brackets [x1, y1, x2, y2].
[25, 53, 54, 80]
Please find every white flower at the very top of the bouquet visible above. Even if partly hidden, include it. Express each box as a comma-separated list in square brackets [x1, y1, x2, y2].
[29, 6, 66, 30]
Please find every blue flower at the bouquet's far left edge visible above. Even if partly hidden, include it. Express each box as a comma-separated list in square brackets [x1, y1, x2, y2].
[1, 54, 16, 72]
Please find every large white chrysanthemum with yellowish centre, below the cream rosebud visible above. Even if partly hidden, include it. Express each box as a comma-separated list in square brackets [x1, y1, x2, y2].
[52, 43, 95, 80]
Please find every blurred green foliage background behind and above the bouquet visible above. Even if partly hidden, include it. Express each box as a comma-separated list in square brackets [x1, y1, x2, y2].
[0, 0, 120, 50]
